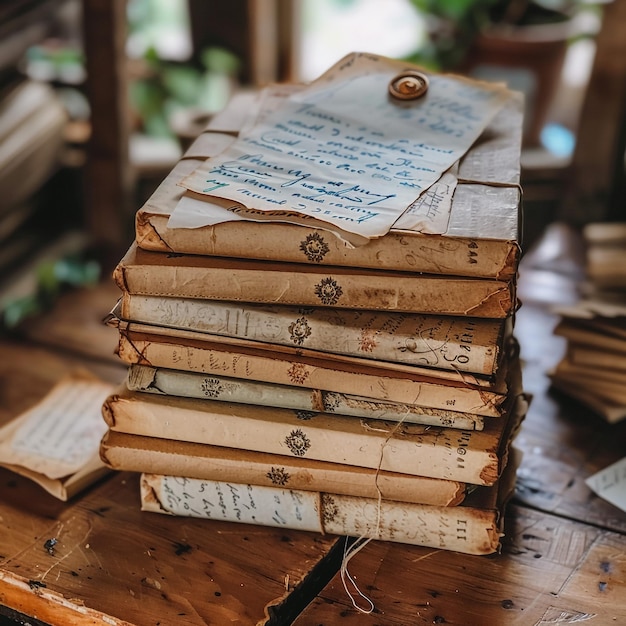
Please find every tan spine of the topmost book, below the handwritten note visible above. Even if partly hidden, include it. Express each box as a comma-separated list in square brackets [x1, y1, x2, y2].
[135, 209, 520, 280]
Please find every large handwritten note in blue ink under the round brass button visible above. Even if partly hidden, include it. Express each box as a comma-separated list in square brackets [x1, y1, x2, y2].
[178, 54, 509, 238]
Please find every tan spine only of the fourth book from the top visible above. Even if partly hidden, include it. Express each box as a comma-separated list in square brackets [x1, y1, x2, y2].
[118, 328, 506, 417]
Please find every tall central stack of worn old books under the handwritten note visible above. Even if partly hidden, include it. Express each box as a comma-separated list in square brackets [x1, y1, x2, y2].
[101, 52, 526, 554]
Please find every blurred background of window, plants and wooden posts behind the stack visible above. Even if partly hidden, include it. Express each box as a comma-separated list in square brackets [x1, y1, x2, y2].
[0, 0, 626, 325]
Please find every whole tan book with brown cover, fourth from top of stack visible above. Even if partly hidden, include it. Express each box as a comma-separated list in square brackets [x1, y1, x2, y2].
[113, 321, 519, 416]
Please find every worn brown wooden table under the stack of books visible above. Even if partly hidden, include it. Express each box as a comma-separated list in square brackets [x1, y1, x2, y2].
[0, 227, 626, 626]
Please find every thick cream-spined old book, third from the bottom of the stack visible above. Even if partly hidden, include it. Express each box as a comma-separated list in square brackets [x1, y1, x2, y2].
[103, 387, 527, 485]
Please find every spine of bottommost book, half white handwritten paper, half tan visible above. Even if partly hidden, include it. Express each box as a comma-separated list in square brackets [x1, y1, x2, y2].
[141, 475, 500, 554]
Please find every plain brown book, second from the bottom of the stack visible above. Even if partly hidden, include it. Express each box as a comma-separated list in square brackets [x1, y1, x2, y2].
[100, 430, 468, 506]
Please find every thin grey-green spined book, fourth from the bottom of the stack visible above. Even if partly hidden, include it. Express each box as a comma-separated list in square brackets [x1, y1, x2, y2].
[126, 365, 488, 428]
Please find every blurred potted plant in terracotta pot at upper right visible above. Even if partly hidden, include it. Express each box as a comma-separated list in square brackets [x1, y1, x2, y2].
[410, 0, 584, 145]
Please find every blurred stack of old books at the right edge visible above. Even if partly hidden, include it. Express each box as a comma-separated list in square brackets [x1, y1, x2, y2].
[550, 223, 626, 422]
